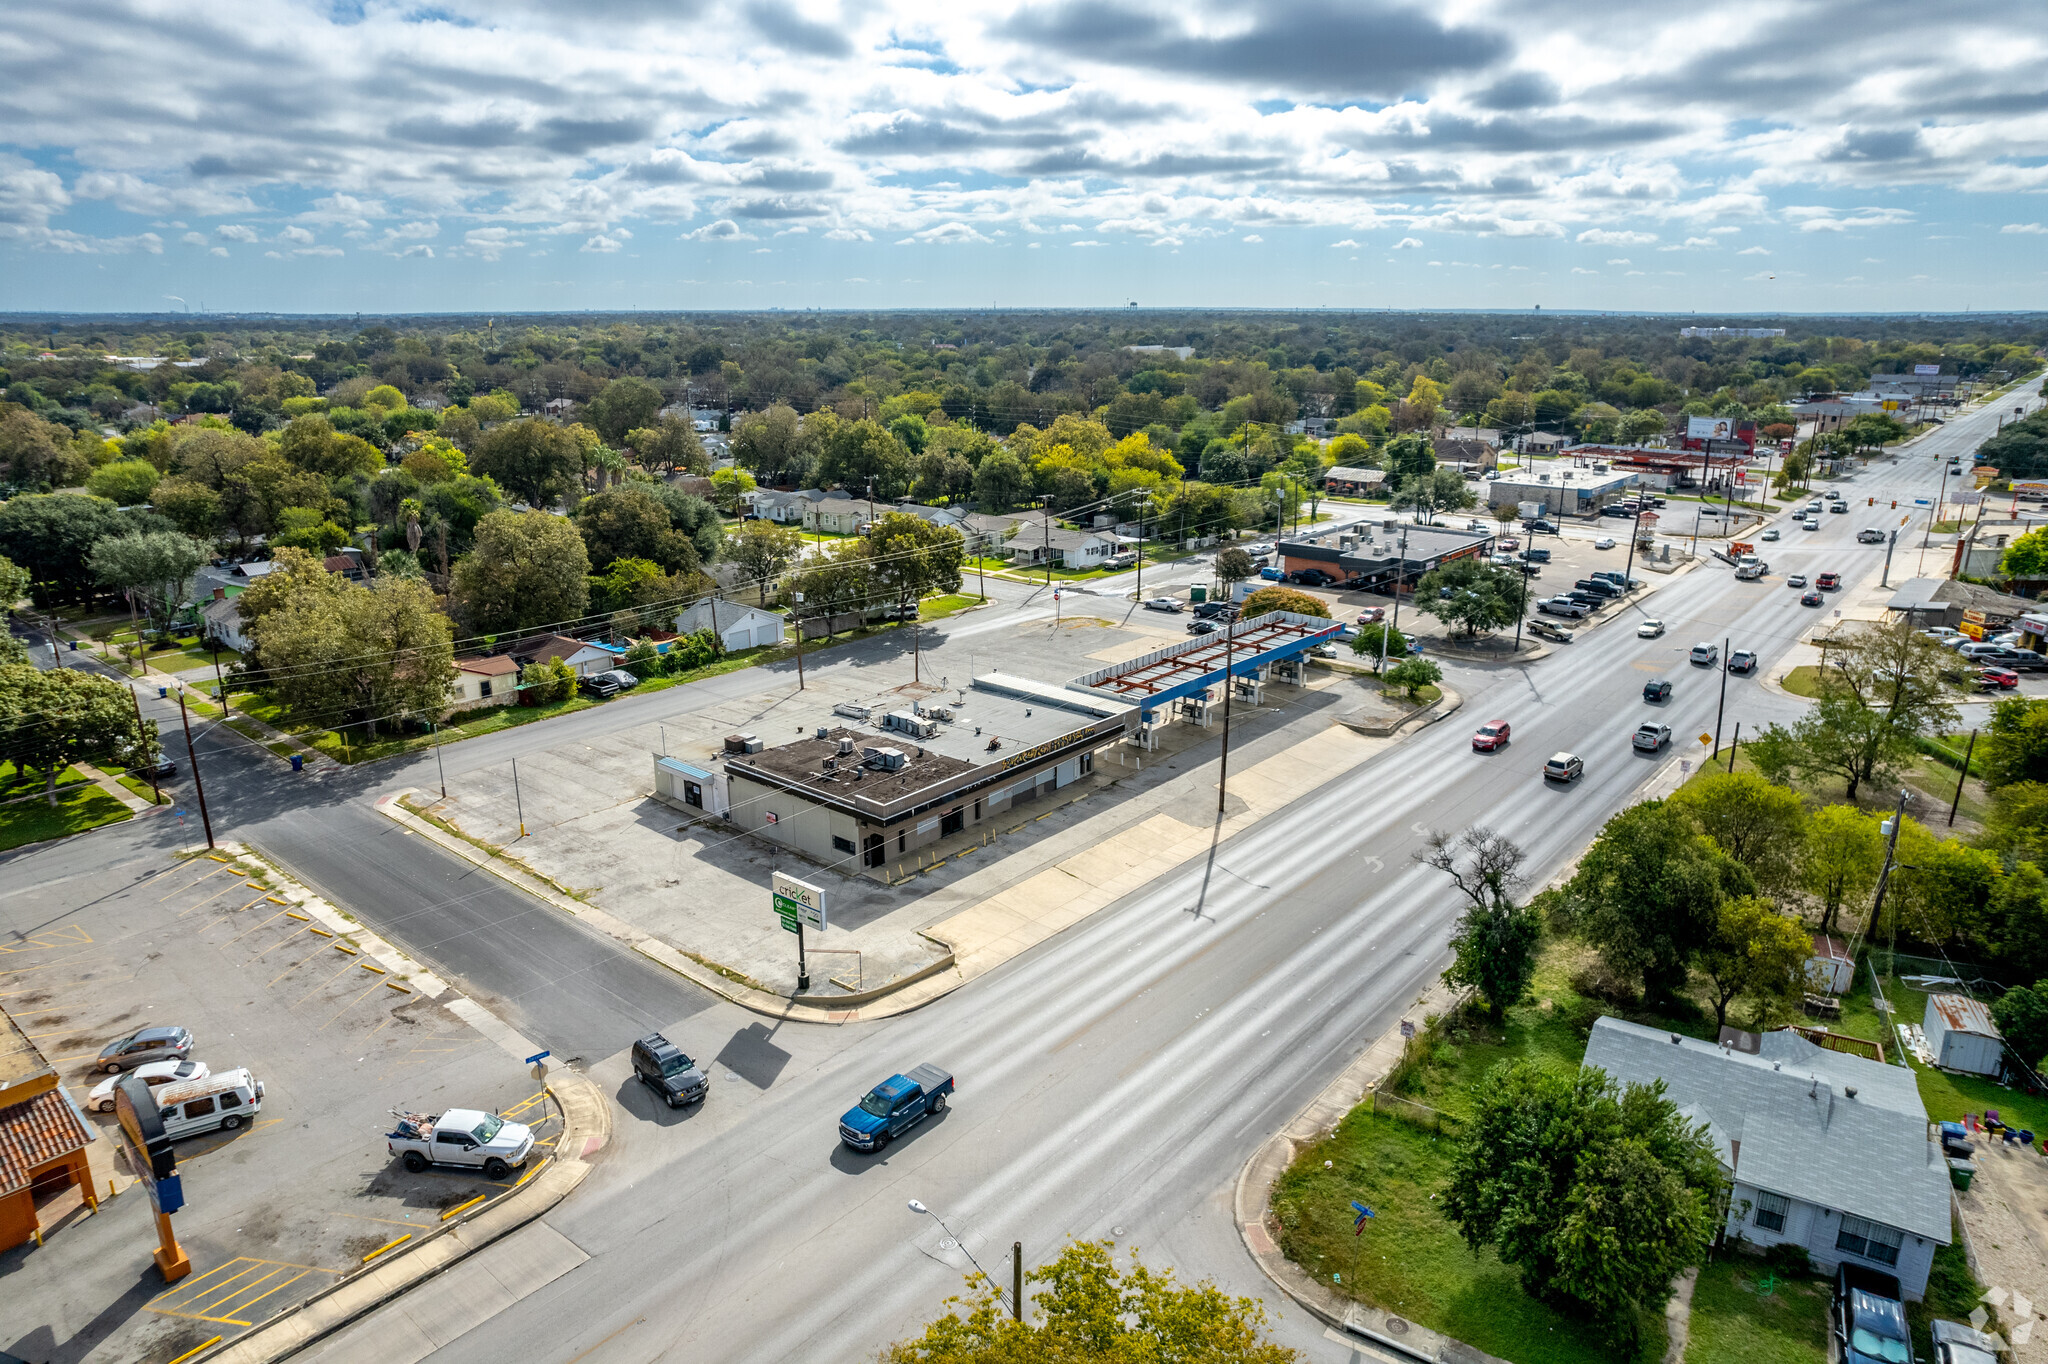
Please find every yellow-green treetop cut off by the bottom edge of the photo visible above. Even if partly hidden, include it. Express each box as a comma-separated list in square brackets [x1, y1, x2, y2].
[881, 1241, 1300, 1364]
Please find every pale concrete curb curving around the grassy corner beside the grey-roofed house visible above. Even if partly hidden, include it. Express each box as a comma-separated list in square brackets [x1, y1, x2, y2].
[1231, 979, 1505, 1364]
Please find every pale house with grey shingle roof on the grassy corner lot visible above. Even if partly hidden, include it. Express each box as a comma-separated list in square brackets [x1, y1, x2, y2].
[1585, 1018, 1952, 1303]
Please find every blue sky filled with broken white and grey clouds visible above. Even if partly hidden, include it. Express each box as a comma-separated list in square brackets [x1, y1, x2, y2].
[0, 0, 2048, 313]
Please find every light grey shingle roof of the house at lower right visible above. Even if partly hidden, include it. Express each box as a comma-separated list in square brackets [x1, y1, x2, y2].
[1585, 1018, 1950, 1245]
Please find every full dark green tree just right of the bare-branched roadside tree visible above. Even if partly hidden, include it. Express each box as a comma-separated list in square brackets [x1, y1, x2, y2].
[1550, 801, 1755, 1004]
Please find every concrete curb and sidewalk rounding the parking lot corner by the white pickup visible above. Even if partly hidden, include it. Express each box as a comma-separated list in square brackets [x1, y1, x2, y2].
[197, 1071, 612, 1364]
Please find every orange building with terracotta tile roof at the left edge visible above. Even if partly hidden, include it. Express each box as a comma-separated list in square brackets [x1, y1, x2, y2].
[0, 1012, 100, 1251]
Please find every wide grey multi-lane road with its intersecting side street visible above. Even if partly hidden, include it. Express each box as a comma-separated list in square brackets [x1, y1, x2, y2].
[10, 385, 2019, 1364]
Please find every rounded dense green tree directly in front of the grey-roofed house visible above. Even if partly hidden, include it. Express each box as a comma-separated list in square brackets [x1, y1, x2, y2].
[1444, 1061, 1726, 1354]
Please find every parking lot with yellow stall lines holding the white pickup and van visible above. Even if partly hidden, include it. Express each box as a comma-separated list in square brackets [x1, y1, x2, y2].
[0, 843, 559, 1364]
